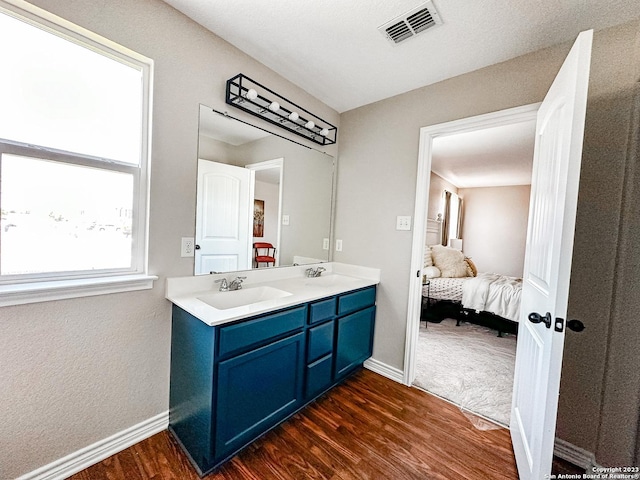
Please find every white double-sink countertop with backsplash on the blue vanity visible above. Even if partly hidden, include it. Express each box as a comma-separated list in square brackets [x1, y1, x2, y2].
[165, 262, 380, 326]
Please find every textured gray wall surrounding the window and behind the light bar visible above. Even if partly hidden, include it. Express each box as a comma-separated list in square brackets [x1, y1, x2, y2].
[0, 0, 339, 479]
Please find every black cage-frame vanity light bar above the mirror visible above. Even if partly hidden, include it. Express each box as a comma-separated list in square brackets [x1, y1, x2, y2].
[226, 73, 338, 145]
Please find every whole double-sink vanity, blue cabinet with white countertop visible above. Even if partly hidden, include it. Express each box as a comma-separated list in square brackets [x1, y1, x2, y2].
[167, 263, 379, 475]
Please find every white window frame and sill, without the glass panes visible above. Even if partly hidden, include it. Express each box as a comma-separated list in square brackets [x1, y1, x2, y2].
[0, 0, 158, 307]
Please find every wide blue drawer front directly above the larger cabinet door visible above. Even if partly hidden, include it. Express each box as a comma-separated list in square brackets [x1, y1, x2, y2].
[218, 305, 307, 357]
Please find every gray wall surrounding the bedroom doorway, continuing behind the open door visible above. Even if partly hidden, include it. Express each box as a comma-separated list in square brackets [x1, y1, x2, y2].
[335, 20, 640, 465]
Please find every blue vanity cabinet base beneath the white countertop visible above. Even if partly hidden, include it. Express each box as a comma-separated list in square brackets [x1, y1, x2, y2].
[169, 287, 375, 476]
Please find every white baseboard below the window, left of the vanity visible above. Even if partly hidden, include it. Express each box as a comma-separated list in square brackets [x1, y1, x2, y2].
[17, 411, 169, 480]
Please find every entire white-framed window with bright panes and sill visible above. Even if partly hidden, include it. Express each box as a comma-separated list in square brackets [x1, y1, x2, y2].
[0, 2, 154, 305]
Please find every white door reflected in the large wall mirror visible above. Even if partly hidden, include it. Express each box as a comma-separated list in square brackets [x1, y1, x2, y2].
[195, 160, 254, 275]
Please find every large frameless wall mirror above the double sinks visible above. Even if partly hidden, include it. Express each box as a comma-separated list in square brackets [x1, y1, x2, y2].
[195, 105, 334, 275]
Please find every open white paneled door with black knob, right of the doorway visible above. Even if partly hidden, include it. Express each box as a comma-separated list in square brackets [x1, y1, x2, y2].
[510, 31, 593, 480]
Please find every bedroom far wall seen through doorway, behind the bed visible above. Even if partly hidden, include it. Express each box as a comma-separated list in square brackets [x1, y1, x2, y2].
[458, 185, 531, 277]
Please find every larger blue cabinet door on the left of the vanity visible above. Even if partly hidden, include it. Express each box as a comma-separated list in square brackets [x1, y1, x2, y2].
[215, 333, 304, 460]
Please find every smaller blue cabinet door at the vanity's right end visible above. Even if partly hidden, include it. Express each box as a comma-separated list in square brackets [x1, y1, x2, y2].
[335, 307, 376, 379]
